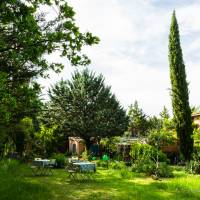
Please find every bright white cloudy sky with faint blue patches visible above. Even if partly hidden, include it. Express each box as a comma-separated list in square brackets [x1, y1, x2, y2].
[38, 0, 200, 115]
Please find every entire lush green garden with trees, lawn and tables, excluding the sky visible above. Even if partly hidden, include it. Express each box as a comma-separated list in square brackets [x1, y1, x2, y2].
[0, 0, 200, 200]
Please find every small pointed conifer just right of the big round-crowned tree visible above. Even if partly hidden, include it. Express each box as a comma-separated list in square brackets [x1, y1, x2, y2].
[128, 101, 148, 136]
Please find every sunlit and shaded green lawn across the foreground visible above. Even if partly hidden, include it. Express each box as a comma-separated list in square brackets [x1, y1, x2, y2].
[0, 162, 200, 200]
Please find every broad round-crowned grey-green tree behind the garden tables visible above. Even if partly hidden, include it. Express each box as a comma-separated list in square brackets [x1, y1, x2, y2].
[49, 69, 127, 147]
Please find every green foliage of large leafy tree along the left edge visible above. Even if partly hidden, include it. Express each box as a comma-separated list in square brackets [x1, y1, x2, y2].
[0, 0, 99, 154]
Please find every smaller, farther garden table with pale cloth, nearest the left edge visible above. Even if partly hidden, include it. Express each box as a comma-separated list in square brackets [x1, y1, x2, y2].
[32, 159, 52, 175]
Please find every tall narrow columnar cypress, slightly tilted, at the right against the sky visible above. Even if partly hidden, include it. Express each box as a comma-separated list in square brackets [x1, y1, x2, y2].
[169, 11, 193, 160]
